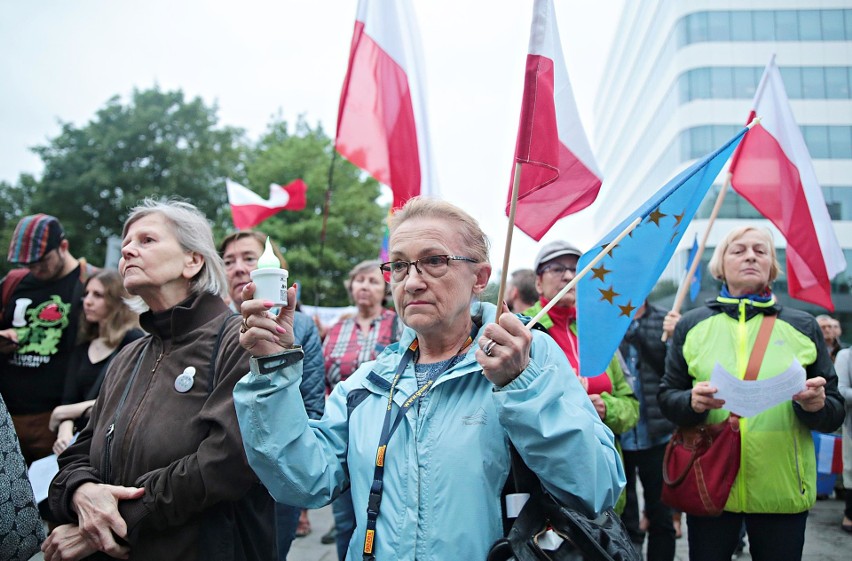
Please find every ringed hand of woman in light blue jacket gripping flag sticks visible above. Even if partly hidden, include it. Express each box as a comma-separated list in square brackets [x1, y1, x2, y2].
[476, 304, 532, 387]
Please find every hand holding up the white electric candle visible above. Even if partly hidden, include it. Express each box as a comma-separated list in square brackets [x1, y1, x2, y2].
[240, 282, 296, 357]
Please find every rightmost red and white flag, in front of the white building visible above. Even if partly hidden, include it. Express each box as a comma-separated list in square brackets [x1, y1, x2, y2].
[730, 56, 846, 311]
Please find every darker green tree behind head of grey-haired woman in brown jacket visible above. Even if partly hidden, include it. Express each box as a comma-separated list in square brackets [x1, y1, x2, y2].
[25, 87, 245, 263]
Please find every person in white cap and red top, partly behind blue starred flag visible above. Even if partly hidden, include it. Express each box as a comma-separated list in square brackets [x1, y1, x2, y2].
[523, 241, 639, 506]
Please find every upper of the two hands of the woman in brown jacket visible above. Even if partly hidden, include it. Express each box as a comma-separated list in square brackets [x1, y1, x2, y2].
[71, 482, 145, 559]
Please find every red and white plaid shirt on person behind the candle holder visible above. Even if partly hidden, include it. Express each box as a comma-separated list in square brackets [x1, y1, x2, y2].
[322, 310, 402, 391]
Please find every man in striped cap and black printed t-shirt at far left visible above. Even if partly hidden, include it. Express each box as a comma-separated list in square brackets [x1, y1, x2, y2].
[0, 214, 88, 464]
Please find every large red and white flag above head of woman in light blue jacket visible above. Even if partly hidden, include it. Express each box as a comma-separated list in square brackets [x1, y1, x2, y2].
[335, 0, 438, 208]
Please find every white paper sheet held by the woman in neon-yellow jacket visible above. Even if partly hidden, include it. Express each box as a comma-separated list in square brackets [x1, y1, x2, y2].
[710, 358, 805, 417]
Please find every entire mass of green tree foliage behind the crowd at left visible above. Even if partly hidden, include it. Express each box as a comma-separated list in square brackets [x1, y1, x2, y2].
[0, 87, 387, 306]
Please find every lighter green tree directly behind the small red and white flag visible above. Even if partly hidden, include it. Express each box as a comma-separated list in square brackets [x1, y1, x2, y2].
[238, 118, 387, 306]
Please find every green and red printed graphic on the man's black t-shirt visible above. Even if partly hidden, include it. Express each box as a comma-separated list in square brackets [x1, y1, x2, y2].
[12, 294, 71, 360]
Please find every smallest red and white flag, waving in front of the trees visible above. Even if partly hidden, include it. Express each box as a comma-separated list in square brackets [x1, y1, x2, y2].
[225, 179, 308, 230]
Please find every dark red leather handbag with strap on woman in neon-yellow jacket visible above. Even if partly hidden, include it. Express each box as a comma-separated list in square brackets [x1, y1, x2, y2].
[662, 315, 775, 516]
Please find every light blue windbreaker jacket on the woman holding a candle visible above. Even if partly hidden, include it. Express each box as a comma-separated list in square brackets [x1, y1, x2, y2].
[234, 303, 625, 561]
